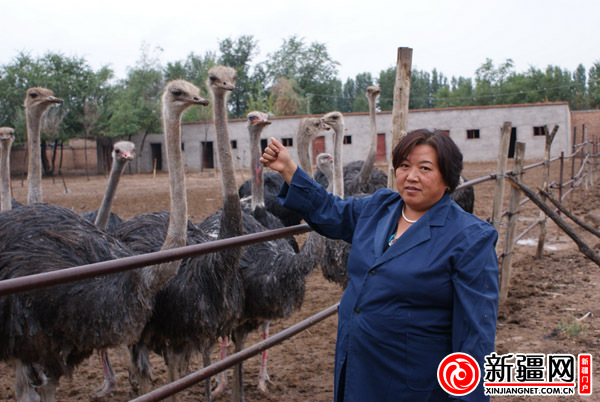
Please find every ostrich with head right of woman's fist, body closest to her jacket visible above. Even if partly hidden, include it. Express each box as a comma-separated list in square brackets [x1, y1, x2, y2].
[203, 115, 325, 401]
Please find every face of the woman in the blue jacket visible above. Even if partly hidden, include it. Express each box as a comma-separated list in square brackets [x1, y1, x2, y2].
[396, 145, 448, 212]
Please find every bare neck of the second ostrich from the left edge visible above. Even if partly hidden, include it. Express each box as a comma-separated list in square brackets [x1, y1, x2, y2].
[25, 109, 44, 204]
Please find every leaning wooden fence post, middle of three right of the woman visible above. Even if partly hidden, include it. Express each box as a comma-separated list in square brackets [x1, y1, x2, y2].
[500, 142, 525, 303]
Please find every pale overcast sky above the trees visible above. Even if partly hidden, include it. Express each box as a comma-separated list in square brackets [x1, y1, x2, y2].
[0, 0, 600, 81]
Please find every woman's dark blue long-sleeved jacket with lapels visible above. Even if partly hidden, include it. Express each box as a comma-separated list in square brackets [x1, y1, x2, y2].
[279, 169, 498, 402]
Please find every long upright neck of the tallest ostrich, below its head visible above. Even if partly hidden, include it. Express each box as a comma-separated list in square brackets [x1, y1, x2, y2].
[213, 91, 243, 240]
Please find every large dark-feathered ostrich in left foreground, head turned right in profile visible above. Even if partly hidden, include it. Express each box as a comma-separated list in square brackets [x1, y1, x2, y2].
[0, 80, 207, 401]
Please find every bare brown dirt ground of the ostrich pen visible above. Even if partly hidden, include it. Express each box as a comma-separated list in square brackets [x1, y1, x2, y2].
[0, 159, 600, 401]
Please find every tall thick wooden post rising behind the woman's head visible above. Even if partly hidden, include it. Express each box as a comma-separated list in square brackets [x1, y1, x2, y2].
[387, 47, 412, 191]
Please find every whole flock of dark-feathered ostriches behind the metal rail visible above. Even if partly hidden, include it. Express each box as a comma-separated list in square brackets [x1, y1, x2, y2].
[0, 66, 474, 401]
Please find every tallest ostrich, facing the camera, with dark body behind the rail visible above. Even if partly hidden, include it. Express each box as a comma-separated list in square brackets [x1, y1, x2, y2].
[122, 66, 243, 399]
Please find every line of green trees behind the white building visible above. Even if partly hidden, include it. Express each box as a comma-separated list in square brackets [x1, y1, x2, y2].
[0, 35, 600, 151]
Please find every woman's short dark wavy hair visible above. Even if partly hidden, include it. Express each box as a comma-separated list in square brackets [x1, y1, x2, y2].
[392, 129, 462, 193]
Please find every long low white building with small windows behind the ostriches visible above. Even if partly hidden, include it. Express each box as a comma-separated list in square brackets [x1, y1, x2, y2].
[135, 102, 572, 172]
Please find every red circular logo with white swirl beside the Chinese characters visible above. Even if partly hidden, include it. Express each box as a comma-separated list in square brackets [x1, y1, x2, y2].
[438, 353, 480, 396]
